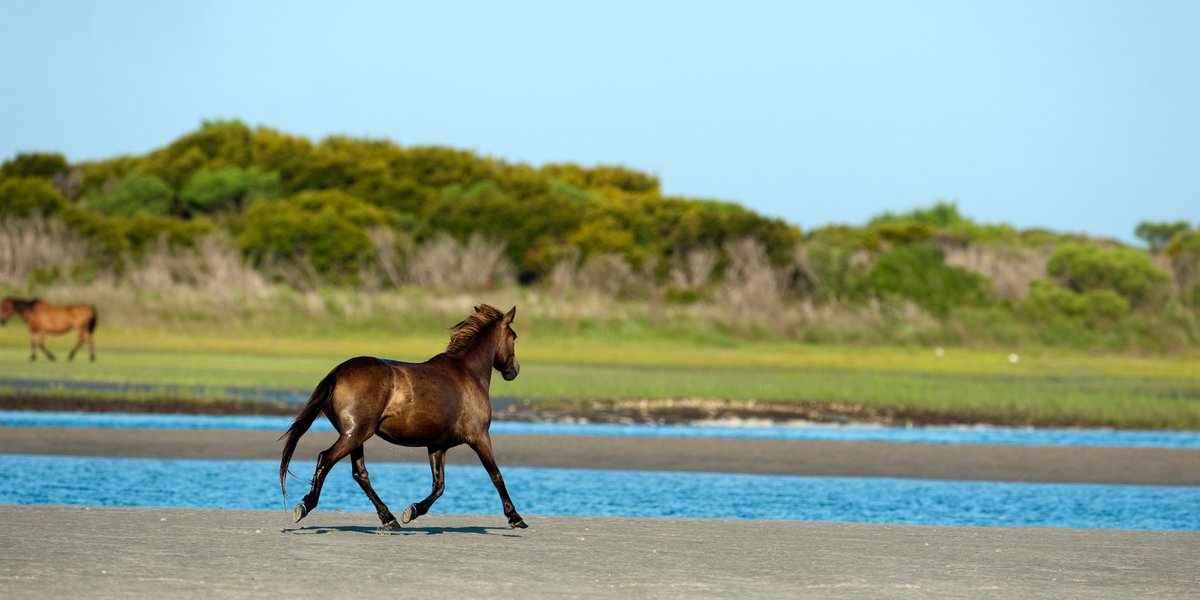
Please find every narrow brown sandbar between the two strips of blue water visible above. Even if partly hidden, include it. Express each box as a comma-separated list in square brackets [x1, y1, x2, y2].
[0, 427, 1200, 486]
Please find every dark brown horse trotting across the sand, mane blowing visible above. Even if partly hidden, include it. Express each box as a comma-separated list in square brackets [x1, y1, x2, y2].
[280, 305, 526, 528]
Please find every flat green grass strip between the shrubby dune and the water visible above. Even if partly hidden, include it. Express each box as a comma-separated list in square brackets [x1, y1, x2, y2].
[0, 328, 1200, 430]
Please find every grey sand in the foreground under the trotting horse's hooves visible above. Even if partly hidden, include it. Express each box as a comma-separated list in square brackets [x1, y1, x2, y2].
[0, 505, 1200, 600]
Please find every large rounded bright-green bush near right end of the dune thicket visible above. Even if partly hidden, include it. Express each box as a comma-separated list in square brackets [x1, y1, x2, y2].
[1046, 244, 1170, 308]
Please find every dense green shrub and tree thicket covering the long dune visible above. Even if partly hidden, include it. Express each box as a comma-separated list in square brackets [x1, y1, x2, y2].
[0, 121, 1200, 343]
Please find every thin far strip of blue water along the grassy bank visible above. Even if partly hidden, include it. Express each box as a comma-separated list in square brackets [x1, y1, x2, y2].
[0, 410, 1200, 448]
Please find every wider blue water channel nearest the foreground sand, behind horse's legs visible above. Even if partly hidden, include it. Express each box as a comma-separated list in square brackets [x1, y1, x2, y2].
[0, 455, 1200, 530]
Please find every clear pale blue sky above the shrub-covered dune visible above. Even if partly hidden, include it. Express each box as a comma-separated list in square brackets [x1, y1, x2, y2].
[0, 0, 1200, 240]
